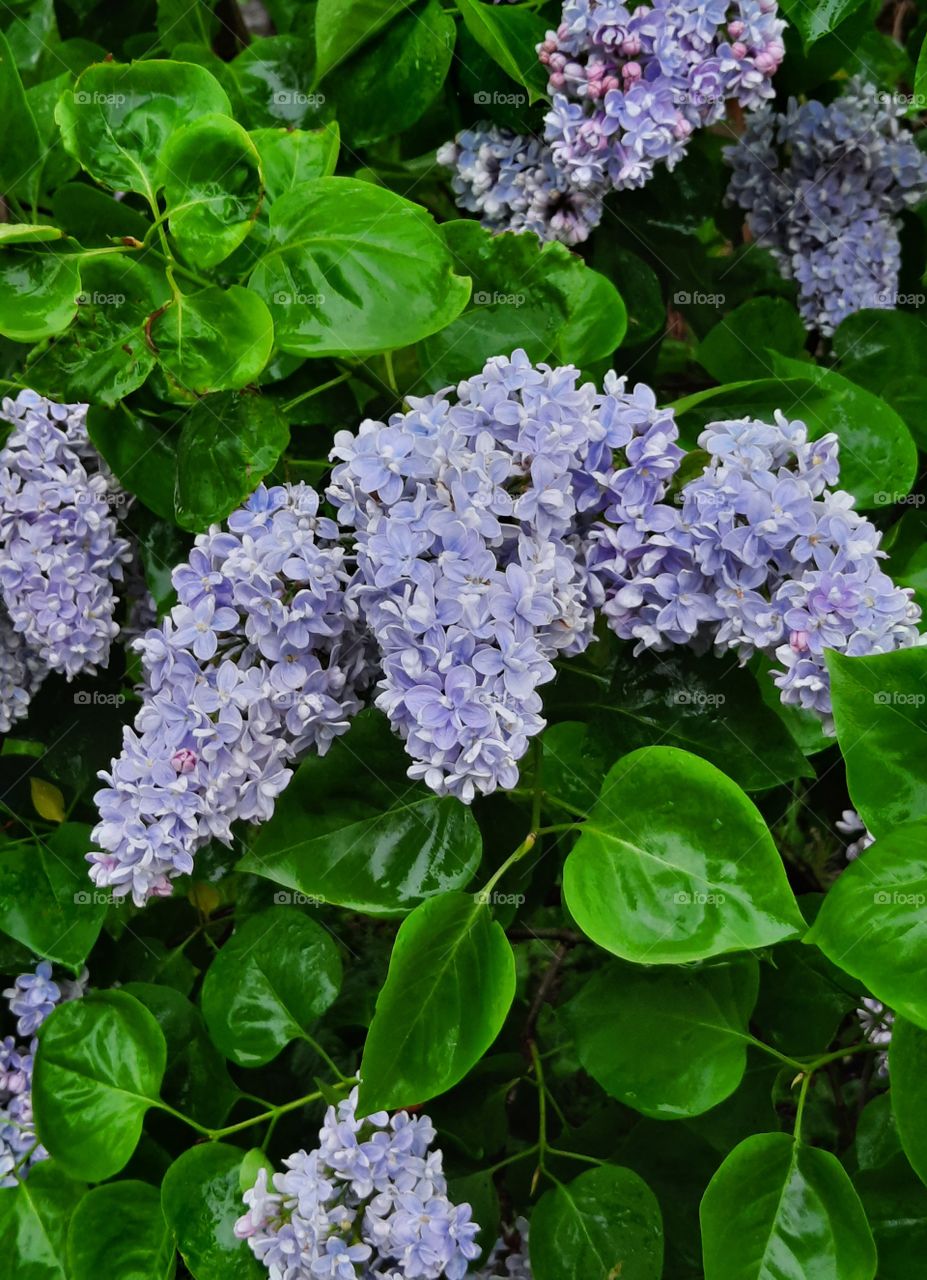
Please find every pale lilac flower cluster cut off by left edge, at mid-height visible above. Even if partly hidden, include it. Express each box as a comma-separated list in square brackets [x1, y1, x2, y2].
[0, 392, 129, 706]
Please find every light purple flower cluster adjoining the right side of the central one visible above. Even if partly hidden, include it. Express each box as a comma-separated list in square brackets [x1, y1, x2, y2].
[590, 412, 921, 721]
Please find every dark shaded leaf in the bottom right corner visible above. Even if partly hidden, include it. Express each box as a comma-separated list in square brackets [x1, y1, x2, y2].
[854, 1156, 927, 1280]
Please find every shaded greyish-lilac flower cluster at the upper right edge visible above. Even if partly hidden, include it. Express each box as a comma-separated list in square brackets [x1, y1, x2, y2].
[726, 79, 927, 334]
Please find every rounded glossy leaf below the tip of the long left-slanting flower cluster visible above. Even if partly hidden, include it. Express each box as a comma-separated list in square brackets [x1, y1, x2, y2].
[201, 906, 341, 1066]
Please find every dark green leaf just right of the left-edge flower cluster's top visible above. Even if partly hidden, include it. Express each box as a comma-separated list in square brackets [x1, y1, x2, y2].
[87, 403, 177, 520]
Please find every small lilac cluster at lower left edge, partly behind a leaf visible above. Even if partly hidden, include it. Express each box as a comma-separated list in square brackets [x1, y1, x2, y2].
[0, 960, 87, 1187]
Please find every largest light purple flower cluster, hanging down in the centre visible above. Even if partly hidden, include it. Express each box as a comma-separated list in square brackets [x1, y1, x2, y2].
[329, 351, 681, 803]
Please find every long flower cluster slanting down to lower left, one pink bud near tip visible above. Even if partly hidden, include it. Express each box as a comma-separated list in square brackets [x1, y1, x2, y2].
[88, 485, 366, 905]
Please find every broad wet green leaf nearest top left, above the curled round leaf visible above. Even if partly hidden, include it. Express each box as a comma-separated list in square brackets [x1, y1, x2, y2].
[55, 59, 230, 199]
